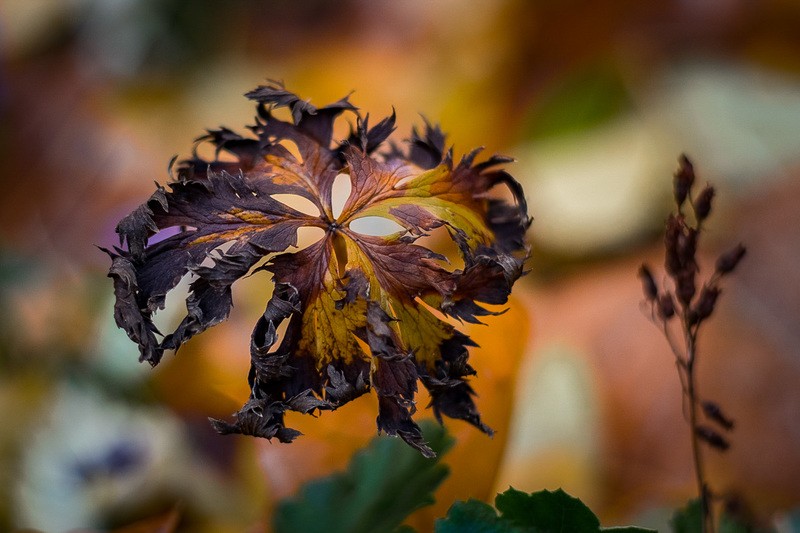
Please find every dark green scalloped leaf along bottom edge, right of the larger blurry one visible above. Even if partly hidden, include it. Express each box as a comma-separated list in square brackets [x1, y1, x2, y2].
[436, 488, 652, 533]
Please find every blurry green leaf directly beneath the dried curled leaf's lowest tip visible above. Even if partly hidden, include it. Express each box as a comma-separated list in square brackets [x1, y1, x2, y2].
[273, 423, 453, 533]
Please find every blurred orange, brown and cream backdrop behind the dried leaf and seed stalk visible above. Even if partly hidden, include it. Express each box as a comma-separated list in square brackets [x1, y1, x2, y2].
[0, 0, 800, 532]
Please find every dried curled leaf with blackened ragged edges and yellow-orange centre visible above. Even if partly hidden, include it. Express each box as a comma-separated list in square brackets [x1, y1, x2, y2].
[106, 84, 530, 456]
